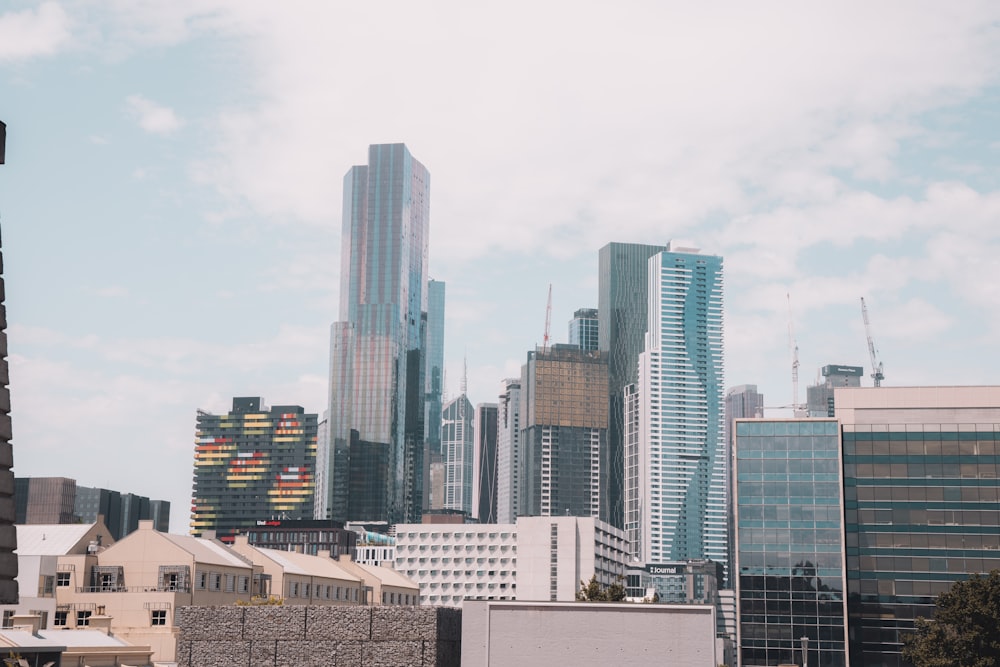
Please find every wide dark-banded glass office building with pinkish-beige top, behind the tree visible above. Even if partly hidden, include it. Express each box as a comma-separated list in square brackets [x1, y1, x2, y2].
[834, 387, 1000, 667]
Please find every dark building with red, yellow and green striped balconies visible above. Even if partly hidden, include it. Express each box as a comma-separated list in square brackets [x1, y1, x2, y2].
[191, 397, 317, 543]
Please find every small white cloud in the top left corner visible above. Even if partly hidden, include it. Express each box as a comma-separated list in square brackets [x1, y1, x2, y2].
[0, 2, 70, 63]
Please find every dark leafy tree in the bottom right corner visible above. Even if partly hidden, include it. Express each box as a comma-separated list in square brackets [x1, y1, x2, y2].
[903, 570, 1000, 667]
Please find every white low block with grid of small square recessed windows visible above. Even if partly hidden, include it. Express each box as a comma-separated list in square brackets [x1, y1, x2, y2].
[395, 517, 627, 606]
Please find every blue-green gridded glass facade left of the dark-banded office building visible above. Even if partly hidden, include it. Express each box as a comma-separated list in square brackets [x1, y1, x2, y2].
[733, 419, 848, 667]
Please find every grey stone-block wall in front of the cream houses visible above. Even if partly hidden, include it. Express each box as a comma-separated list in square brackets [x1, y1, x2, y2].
[174, 606, 462, 667]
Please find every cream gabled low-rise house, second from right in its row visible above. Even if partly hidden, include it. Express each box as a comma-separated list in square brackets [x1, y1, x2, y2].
[231, 535, 364, 605]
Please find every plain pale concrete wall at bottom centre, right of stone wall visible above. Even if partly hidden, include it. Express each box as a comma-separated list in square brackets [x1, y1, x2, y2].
[462, 600, 721, 667]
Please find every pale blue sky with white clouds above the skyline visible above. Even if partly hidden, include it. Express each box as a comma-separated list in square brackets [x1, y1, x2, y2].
[0, 0, 1000, 532]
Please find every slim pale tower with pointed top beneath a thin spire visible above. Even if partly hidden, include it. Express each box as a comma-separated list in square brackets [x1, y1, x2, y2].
[441, 394, 475, 516]
